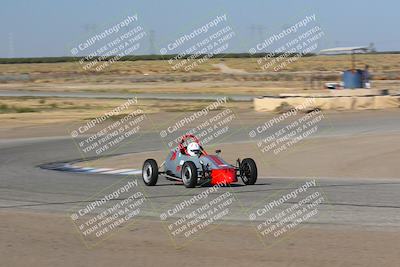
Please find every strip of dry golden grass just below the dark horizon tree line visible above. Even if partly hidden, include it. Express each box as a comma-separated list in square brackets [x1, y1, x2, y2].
[0, 54, 400, 74]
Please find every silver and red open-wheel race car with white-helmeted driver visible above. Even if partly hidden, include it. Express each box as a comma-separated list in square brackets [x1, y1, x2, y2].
[142, 134, 257, 188]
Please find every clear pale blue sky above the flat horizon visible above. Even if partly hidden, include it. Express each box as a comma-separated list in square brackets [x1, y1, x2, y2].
[0, 0, 400, 57]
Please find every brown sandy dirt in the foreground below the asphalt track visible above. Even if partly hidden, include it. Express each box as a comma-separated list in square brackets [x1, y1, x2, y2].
[0, 210, 400, 267]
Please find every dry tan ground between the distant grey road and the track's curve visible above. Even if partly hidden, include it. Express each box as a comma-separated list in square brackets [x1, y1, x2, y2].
[0, 97, 252, 139]
